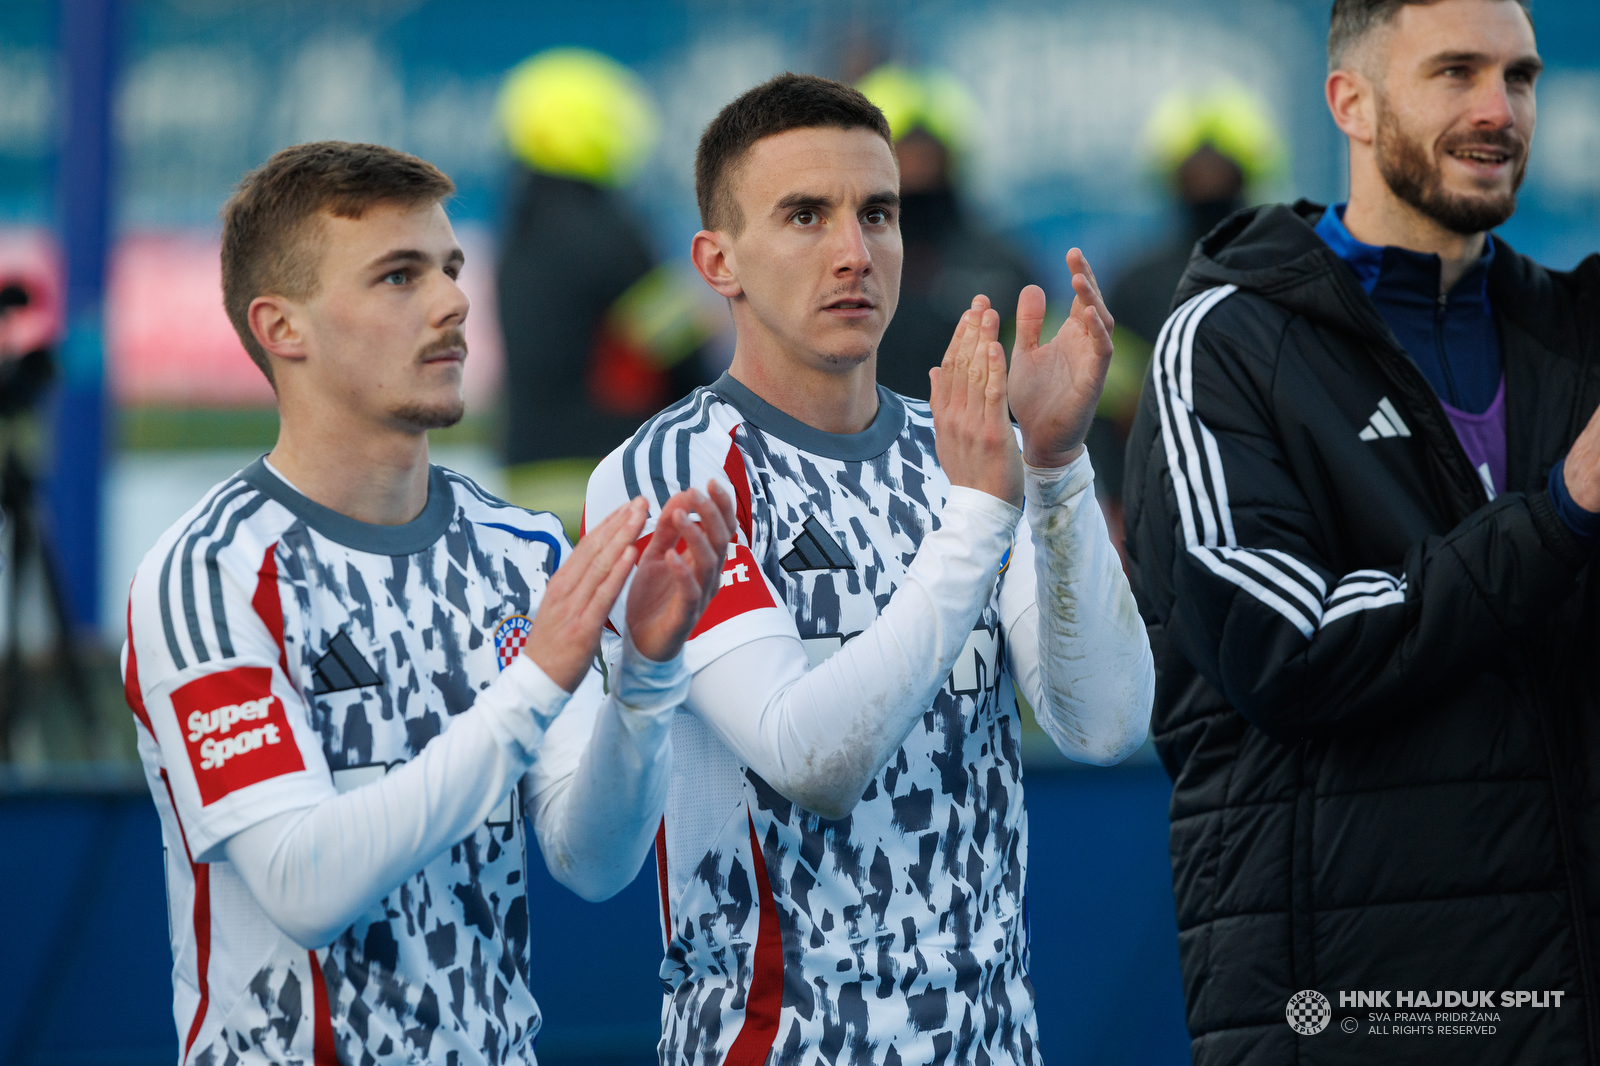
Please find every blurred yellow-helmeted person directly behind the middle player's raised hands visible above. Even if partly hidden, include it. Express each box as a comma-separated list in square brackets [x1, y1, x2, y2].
[858, 66, 1034, 399]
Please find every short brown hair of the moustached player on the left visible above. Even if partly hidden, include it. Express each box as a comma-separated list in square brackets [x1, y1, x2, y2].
[222, 141, 456, 381]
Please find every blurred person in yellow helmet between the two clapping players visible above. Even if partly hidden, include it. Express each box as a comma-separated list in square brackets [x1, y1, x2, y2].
[498, 48, 715, 530]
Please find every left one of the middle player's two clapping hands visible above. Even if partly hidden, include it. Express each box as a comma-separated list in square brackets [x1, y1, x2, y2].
[928, 296, 1022, 507]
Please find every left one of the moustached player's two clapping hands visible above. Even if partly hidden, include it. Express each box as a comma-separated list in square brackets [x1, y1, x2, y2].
[522, 498, 650, 691]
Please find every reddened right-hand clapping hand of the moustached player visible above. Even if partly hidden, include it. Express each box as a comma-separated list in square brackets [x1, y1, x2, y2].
[627, 482, 736, 663]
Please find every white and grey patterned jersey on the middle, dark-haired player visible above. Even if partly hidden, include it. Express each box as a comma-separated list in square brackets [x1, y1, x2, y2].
[587, 375, 1038, 1066]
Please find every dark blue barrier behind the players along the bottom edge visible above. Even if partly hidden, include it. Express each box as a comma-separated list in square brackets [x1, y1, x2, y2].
[0, 765, 1189, 1066]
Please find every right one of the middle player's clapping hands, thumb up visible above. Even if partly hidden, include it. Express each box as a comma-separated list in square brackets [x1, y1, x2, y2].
[1011, 248, 1115, 466]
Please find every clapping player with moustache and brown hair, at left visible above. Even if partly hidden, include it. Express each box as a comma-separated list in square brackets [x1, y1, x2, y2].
[125, 142, 733, 1066]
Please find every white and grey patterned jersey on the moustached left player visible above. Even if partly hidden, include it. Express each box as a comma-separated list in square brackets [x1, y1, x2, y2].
[123, 459, 568, 1066]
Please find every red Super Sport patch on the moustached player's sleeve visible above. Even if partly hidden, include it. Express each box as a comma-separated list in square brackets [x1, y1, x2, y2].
[173, 666, 306, 807]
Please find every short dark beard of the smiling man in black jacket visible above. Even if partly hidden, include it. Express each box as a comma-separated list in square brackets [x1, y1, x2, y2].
[1373, 94, 1528, 237]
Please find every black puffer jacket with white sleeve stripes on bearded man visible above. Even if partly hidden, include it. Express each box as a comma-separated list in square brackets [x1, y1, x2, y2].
[1126, 203, 1600, 1066]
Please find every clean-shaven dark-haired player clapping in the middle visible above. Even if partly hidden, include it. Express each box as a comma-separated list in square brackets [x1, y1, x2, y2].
[587, 75, 1154, 1066]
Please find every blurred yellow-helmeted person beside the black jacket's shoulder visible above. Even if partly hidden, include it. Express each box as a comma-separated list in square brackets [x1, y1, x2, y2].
[1090, 83, 1283, 546]
